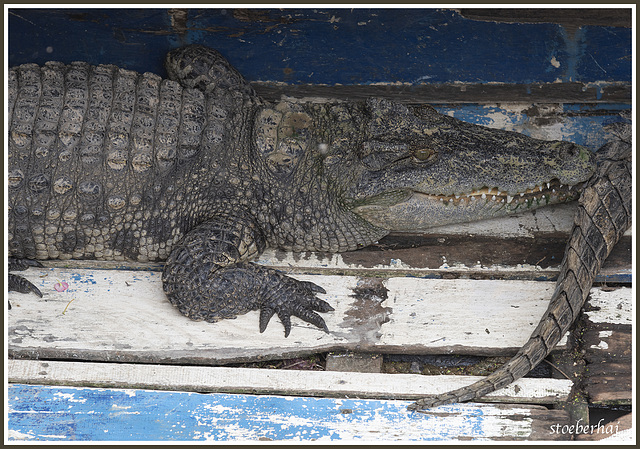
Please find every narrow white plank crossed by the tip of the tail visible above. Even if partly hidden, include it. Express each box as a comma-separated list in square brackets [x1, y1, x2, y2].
[7, 360, 573, 404]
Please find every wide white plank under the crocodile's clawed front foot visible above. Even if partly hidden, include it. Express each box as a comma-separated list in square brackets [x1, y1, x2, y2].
[8, 269, 584, 364]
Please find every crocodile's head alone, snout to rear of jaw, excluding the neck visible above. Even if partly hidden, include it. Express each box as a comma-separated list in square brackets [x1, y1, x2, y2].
[323, 99, 595, 231]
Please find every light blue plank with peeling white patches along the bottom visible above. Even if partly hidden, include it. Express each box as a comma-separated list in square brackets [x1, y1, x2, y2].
[8, 385, 570, 442]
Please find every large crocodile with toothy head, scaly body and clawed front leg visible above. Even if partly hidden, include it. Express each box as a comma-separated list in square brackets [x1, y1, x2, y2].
[8, 45, 596, 337]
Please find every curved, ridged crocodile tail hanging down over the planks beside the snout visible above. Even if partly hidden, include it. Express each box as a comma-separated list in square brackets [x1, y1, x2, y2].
[409, 124, 632, 411]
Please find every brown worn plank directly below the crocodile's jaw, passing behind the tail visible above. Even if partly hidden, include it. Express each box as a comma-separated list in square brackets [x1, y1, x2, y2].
[257, 235, 633, 283]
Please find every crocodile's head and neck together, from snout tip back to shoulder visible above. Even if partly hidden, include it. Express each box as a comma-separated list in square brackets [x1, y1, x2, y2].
[252, 99, 595, 248]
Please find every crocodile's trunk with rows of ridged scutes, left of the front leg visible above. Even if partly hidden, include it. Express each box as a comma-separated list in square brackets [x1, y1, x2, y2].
[8, 62, 207, 260]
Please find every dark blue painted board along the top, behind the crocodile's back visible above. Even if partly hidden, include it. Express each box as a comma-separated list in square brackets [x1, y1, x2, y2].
[8, 8, 631, 85]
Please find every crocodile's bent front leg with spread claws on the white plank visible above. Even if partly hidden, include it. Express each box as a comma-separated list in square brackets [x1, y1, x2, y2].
[162, 215, 334, 337]
